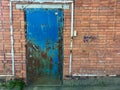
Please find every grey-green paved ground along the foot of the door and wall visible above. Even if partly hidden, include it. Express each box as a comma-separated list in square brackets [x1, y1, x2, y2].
[24, 77, 120, 90]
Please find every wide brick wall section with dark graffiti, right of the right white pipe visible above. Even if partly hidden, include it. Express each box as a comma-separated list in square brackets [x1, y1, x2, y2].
[72, 0, 120, 75]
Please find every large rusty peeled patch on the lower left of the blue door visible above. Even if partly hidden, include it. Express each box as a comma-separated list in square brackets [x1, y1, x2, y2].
[27, 42, 53, 82]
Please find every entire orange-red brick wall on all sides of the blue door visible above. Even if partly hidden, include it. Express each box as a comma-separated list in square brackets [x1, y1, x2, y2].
[0, 0, 120, 78]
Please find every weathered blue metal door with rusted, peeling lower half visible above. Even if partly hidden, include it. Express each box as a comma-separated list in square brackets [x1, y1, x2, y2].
[25, 9, 63, 84]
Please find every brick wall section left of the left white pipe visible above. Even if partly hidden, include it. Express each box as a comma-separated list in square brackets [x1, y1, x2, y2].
[0, 0, 11, 74]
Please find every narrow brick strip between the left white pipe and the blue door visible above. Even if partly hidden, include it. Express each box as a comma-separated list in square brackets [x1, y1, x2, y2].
[13, 3, 26, 78]
